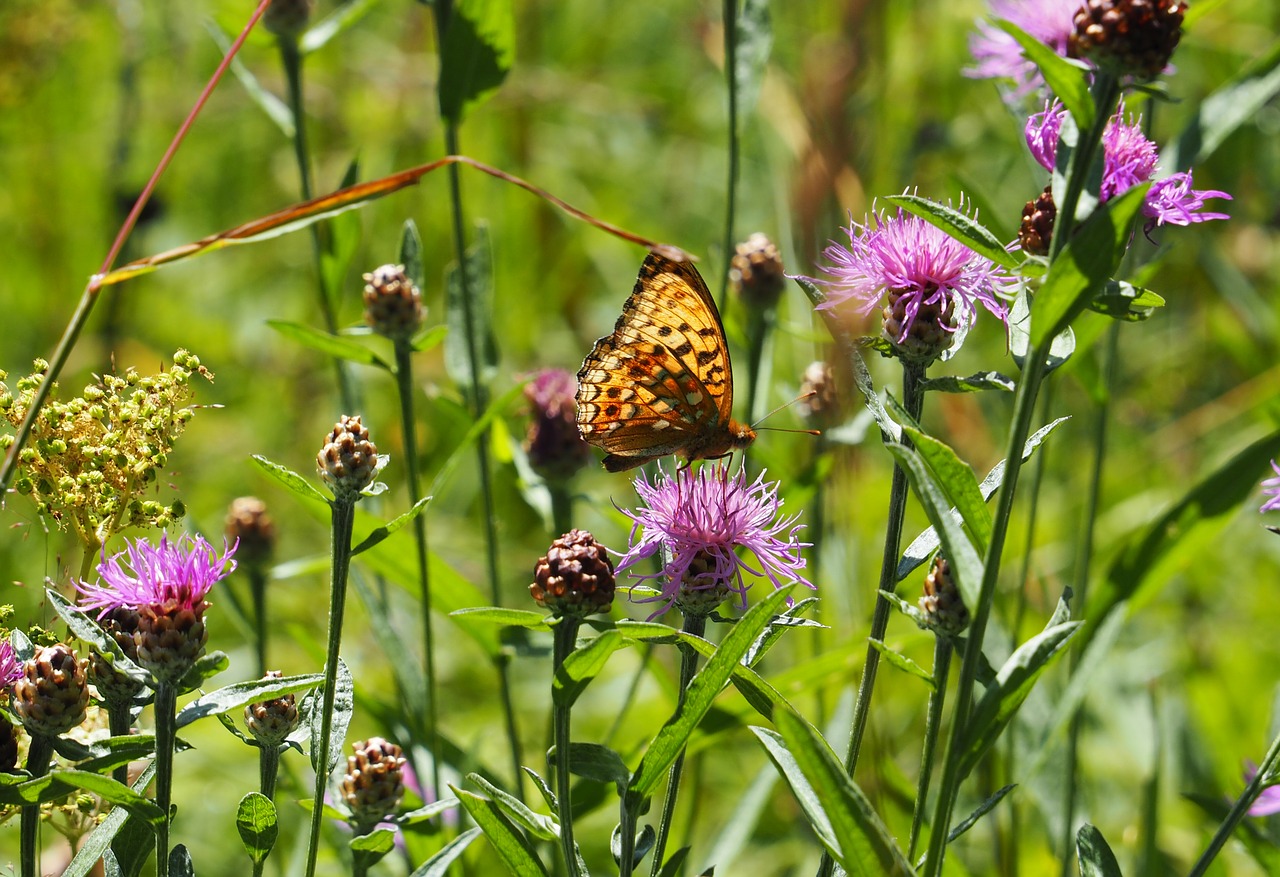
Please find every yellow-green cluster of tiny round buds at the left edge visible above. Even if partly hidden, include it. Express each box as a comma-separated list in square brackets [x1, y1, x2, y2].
[0, 350, 212, 542]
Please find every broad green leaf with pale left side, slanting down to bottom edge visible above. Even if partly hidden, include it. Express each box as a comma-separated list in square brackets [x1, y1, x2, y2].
[751, 709, 915, 877]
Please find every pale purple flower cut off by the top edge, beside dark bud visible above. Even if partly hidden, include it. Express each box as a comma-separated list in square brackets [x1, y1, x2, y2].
[964, 0, 1080, 104]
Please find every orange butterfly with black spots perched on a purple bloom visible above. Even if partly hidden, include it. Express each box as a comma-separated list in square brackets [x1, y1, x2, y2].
[577, 247, 755, 472]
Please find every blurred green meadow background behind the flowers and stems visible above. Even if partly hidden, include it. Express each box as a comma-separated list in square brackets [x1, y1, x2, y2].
[0, 0, 1280, 874]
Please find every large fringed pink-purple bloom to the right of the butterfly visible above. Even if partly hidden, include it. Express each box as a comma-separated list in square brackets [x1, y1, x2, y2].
[815, 201, 1015, 343]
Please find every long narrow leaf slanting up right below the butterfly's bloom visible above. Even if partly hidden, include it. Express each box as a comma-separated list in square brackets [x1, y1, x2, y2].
[627, 588, 791, 798]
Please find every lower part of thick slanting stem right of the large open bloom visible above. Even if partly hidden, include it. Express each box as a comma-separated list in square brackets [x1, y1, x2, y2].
[924, 348, 1052, 877]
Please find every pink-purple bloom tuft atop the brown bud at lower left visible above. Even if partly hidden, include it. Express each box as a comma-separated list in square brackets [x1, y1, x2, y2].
[76, 534, 238, 618]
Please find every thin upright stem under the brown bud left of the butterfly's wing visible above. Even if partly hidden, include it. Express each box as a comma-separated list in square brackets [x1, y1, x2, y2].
[394, 338, 440, 799]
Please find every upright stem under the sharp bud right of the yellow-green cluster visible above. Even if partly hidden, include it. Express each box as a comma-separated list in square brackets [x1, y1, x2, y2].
[306, 494, 358, 877]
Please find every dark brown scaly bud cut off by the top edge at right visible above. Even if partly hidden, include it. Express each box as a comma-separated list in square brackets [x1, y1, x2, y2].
[1068, 0, 1187, 81]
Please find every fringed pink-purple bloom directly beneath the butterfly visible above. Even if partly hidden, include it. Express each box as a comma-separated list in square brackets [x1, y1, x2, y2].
[618, 465, 814, 618]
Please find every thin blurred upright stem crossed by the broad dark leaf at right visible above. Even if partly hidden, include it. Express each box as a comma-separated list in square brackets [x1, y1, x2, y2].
[1061, 321, 1120, 877]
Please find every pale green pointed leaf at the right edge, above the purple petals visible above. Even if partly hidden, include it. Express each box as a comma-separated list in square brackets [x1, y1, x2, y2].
[1160, 42, 1280, 172]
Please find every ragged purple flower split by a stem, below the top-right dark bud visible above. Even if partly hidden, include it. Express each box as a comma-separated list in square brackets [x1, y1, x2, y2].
[1024, 101, 1231, 232]
